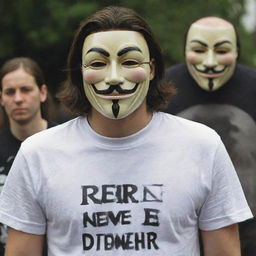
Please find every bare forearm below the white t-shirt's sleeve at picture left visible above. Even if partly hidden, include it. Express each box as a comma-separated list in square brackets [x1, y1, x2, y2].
[5, 228, 44, 256]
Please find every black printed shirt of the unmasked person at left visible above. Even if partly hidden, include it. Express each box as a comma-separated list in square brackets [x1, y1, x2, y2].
[0, 122, 56, 256]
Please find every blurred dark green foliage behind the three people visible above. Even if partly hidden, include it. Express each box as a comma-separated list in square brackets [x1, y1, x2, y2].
[0, 0, 256, 92]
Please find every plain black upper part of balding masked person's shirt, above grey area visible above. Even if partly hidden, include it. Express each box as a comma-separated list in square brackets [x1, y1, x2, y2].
[166, 64, 256, 120]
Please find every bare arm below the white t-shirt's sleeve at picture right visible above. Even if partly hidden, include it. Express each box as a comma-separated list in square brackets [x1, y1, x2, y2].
[201, 224, 241, 256]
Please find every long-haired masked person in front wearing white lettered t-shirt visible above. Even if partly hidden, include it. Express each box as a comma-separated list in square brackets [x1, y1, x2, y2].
[0, 6, 252, 256]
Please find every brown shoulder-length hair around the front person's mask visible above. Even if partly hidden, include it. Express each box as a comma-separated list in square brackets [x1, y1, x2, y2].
[57, 6, 175, 115]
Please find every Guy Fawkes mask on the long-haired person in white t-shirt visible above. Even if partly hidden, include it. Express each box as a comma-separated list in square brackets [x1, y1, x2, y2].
[82, 30, 154, 119]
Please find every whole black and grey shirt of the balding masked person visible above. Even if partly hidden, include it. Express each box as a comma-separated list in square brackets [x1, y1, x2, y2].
[166, 64, 256, 256]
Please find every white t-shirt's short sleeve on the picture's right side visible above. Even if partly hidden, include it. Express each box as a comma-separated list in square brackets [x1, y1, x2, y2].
[199, 142, 252, 230]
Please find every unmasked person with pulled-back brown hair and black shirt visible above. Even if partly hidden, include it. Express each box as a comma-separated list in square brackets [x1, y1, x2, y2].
[0, 57, 55, 255]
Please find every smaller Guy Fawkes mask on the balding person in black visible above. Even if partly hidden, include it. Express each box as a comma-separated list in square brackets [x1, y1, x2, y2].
[185, 24, 237, 91]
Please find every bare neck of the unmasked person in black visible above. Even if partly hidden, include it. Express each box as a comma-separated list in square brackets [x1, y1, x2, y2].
[10, 117, 47, 141]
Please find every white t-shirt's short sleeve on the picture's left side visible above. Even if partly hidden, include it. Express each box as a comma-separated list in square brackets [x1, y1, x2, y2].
[0, 150, 46, 235]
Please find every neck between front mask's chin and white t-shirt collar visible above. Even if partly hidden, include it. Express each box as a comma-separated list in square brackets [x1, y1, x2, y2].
[87, 102, 152, 138]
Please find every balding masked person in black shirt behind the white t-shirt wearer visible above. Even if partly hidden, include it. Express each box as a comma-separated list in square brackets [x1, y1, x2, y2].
[166, 17, 256, 256]
